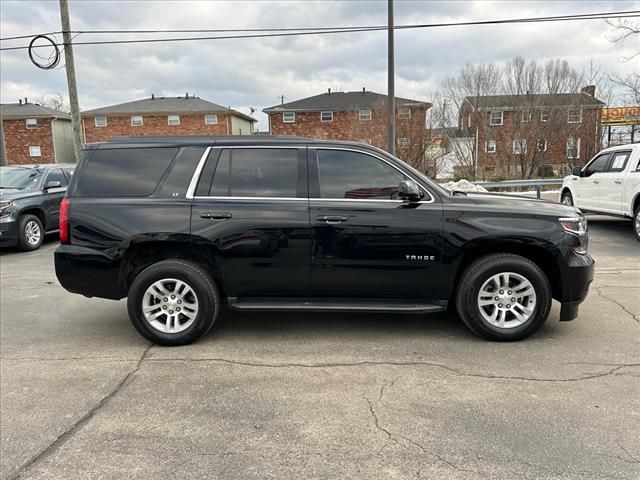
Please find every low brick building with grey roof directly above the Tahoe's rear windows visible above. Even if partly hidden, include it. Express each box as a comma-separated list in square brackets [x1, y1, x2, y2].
[81, 94, 256, 143]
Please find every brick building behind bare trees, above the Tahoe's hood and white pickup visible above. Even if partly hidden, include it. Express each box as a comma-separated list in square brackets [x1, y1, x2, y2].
[459, 86, 604, 178]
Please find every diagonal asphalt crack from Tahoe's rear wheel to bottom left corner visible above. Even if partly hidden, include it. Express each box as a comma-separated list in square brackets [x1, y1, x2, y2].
[7, 344, 153, 480]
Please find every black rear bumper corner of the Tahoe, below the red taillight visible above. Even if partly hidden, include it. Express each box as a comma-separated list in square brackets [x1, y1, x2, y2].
[54, 245, 125, 300]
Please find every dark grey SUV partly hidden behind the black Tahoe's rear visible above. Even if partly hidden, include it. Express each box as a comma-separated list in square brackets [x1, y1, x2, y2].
[0, 163, 76, 250]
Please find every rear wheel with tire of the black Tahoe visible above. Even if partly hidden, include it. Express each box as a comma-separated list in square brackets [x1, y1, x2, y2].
[127, 260, 220, 346]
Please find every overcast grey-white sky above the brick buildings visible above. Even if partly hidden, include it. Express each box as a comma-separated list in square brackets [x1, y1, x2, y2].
[0, 0, 640, 129]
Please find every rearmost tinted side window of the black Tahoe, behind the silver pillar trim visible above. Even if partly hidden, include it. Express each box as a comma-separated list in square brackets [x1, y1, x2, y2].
[75, 148, 178, 197]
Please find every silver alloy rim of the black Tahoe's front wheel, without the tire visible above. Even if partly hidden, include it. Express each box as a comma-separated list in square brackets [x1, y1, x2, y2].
[477, 272, 536, 329]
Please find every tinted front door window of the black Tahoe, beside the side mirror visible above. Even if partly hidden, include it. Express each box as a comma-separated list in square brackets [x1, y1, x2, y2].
[318, 150, 406, 200]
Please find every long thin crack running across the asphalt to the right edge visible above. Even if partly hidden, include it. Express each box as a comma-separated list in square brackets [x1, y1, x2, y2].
[141, 358, 640, 383]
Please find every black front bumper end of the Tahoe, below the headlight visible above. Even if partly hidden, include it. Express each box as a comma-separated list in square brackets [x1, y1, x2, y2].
[560, 254, 595, 321]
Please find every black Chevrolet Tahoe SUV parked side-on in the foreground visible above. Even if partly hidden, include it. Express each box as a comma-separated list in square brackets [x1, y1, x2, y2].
[55, 137, 594, 345]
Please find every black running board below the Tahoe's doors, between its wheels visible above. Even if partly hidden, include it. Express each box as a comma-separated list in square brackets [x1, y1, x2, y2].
[228, 297, 446, 313]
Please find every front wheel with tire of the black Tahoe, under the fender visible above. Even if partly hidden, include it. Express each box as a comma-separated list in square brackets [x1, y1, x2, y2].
[456, 254, 552, 341]
